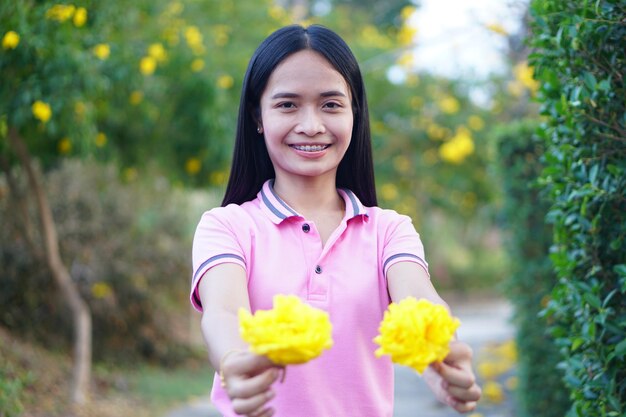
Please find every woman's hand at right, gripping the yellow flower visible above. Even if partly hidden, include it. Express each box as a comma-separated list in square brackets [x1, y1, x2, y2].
[424, 342, 481, 413]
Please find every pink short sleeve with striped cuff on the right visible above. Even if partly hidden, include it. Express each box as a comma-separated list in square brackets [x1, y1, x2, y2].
[382, 211, 430, 276]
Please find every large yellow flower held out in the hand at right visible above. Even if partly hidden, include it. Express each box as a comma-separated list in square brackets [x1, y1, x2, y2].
[374, 297, 461, 374]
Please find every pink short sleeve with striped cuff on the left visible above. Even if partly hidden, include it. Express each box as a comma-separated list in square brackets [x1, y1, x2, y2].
[190, 207, 246, 311]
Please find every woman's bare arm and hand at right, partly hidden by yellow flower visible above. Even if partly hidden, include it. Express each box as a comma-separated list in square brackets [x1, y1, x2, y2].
[387, 262, 481, 413]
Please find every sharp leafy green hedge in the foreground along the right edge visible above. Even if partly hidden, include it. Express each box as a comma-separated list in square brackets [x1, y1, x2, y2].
[530, 0, 626, 417]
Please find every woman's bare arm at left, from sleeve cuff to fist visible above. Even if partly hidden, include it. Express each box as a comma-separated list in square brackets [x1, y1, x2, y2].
[198, 263, 279, 417]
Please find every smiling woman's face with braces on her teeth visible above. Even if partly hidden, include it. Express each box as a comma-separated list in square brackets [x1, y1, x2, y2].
[260, 50, 354, 181]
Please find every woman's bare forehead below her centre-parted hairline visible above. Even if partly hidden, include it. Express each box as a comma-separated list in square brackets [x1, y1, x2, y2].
[265, 50, 350, 96]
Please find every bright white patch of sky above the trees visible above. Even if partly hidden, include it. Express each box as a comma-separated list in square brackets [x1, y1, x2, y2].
[404, 0, 528, 79]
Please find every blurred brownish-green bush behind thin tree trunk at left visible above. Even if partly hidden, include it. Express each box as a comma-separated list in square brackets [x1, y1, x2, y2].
[0, 160, 212, 360]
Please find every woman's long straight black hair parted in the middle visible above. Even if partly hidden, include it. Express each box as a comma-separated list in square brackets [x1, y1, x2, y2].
[222, 25, 377, 206]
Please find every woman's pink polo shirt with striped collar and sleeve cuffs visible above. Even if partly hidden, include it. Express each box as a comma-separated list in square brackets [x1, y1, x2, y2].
[191, 180, 428, 417]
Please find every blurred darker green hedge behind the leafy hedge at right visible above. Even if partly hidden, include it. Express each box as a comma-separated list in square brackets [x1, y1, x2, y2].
[497, 121, 569, 417]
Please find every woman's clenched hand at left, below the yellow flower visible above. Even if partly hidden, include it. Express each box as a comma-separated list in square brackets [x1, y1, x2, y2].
[221, 351, 281, 417]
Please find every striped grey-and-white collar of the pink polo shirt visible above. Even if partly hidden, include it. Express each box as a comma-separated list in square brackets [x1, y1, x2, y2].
[257, 179, 368, 224]
